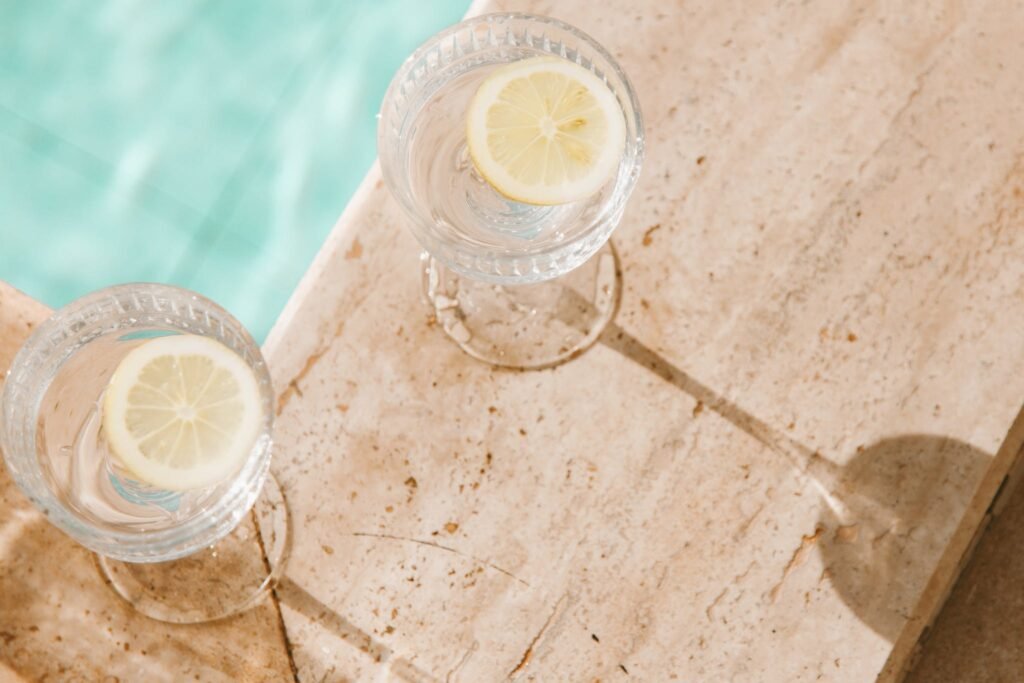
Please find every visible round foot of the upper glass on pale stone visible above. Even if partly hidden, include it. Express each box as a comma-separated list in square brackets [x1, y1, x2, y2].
[423, 242, 622, 370]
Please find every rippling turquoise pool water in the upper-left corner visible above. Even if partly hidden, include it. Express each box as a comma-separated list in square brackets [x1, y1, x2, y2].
[0, 0, 469, 339]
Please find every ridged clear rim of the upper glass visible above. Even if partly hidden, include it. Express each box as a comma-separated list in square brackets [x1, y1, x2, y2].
[377, 12, 645, 282]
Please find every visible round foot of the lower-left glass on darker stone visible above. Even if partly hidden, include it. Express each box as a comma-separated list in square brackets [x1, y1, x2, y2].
[96, 474, 289, 624]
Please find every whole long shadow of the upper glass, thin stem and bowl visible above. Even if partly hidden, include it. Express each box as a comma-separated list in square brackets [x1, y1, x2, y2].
[600, 315, 991, 642]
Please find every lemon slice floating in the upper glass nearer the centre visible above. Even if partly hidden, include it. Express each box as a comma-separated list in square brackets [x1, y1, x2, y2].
[466, 57, 626, 204]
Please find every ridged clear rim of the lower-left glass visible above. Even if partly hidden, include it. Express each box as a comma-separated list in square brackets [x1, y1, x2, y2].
[0, 283, 274, 562]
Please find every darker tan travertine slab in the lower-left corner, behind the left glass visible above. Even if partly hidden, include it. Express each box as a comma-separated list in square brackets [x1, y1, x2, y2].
[0, 283, 292, 683]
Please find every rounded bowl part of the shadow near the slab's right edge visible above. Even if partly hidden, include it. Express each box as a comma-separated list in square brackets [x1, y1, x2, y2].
[819, 434, 991, 642]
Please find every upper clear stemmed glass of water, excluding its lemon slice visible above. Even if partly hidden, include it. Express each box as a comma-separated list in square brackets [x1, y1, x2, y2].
[377, 14, 644, 368]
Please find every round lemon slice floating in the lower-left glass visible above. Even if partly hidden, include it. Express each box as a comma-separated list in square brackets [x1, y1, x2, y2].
[102, 335, 262, 490]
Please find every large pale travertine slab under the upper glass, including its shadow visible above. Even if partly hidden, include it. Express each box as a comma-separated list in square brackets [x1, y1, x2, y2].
[260, 0, 1024, 682]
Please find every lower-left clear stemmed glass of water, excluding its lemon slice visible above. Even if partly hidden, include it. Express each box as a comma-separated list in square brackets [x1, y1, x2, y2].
[0, 284, 288, 623]
